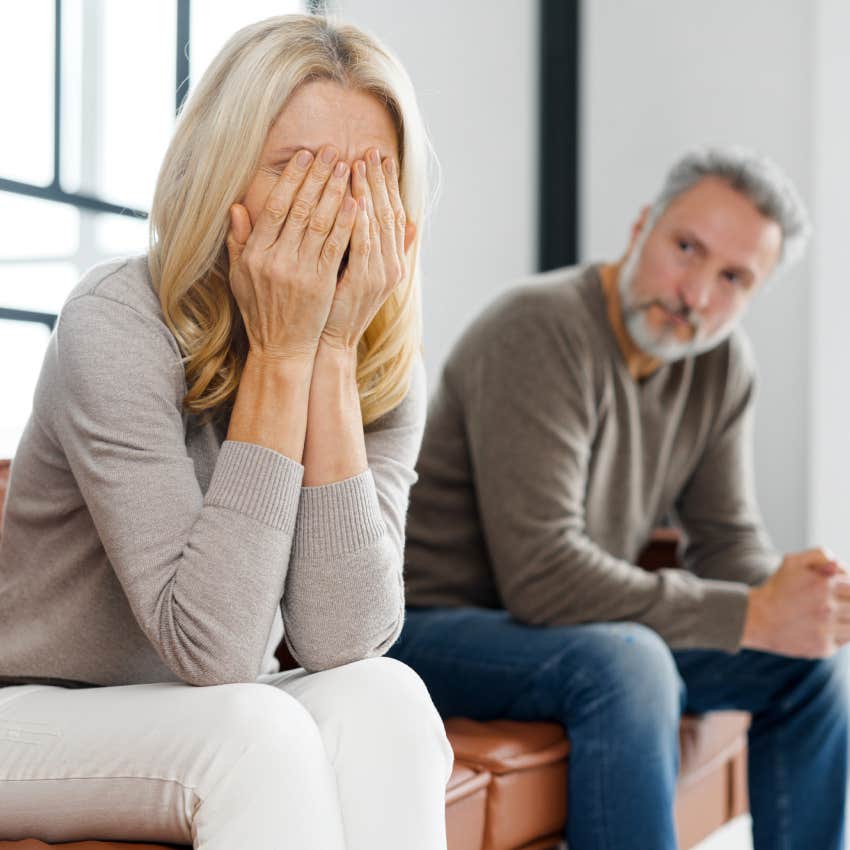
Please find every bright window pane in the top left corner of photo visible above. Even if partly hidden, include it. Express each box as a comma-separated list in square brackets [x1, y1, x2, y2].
[0, 0, 54, 186]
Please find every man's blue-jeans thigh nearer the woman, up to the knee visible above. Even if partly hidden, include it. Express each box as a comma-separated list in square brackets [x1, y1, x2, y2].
[389, 608, 681, 723]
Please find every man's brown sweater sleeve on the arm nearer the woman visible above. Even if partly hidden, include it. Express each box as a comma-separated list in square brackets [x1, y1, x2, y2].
[464, 302, 747, 650]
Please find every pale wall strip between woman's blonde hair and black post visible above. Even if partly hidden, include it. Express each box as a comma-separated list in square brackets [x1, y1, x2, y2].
[331, 0, 538, 386]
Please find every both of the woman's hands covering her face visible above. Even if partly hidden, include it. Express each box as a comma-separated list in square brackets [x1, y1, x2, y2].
[227, 147, 406, 359]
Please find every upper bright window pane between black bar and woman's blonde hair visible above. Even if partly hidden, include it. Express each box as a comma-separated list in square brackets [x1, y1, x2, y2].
[62, 0, 177, 210]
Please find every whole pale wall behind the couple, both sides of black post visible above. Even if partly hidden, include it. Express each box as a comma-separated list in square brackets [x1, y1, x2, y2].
[331, 0, 850, 559]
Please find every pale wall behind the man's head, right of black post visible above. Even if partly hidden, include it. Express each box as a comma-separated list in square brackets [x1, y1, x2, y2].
[580, 0, 812, 557]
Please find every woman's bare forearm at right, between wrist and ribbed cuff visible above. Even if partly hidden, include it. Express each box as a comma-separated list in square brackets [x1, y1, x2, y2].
[303, 342, 368, 487]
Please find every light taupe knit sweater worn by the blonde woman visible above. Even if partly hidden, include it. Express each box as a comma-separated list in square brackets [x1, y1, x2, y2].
[0, 256, 425, 685]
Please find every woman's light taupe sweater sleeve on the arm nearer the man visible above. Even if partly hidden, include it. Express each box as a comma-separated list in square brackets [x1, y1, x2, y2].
[282, 360, 427, 671]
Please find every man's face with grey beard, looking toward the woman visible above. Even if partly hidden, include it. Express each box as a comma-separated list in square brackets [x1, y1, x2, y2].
[619, 177, 782, 361]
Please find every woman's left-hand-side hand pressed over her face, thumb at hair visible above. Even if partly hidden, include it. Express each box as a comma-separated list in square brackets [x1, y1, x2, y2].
[227, 146, 356, 360]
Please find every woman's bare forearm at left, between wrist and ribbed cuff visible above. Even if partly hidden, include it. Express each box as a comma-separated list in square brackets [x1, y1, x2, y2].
[227, 353, 314, 463]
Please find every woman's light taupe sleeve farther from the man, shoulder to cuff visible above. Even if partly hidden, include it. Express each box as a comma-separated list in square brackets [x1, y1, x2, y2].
[52, 294, 303, 685]
